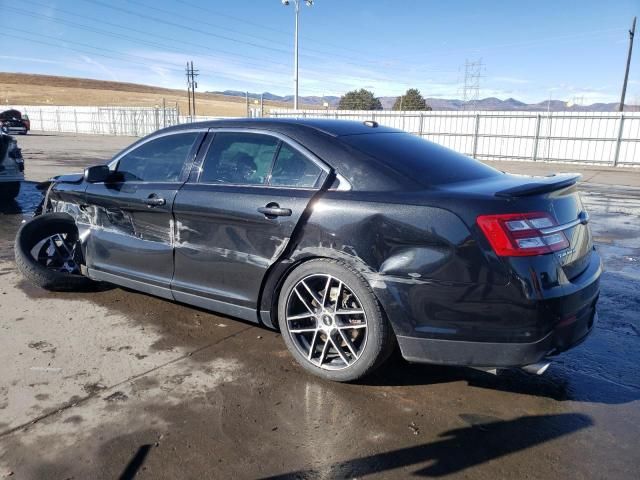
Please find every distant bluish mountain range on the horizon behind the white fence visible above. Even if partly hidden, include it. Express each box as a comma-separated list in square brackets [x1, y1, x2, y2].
[207, 90, 618, 112]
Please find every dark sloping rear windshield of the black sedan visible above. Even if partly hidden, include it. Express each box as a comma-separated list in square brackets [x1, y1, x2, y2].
[340, 133, 501, 185]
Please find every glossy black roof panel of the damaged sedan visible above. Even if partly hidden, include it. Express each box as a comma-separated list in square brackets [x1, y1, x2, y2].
[169, 118, 402, 137]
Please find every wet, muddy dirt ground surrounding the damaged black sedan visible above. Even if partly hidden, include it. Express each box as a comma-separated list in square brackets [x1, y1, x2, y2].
[0, 136, 640, 480]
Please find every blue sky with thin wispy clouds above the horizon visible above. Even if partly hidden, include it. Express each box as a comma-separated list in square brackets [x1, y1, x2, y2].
[0, 0, 640, 104]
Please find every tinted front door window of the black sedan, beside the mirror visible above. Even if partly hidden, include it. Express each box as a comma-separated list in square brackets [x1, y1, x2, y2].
[116, 132, 199, 182]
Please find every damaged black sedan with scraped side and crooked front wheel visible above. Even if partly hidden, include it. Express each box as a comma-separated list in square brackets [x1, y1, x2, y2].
[16, 119, 601, 381]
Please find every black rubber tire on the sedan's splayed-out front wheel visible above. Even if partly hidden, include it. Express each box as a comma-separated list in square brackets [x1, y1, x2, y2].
[15, 213, 95, 292]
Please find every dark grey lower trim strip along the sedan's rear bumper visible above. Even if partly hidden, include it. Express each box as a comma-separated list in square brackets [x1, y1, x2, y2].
[398, 309, 597, 368]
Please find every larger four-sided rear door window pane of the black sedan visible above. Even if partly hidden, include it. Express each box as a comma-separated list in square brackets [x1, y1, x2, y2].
[199, 132, 278, 185]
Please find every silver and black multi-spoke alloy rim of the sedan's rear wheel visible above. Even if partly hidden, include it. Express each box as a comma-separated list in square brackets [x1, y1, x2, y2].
[286, 274, 367, 370]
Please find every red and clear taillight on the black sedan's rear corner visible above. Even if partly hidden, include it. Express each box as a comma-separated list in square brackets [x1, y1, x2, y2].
[477, 212, 569, 257]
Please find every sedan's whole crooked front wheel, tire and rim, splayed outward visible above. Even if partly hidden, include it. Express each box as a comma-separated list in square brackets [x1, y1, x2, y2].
[15, 213, 94, 291]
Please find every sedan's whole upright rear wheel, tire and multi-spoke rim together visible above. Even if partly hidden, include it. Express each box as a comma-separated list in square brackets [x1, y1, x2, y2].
[278, 259, 395, 381]
